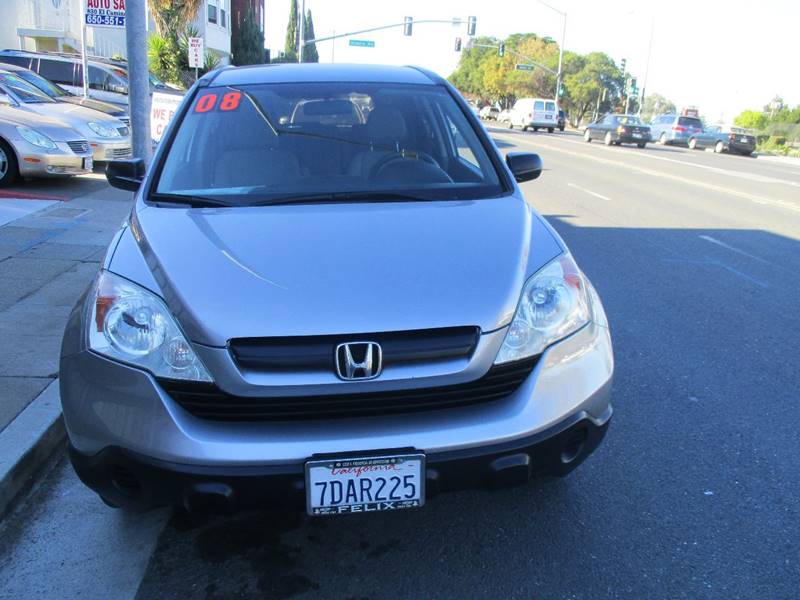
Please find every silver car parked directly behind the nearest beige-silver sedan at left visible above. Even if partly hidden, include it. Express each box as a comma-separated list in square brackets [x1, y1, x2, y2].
[0, 69, 133, 161]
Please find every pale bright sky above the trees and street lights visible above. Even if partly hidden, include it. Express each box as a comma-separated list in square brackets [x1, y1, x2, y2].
[265, 0, 800, 121]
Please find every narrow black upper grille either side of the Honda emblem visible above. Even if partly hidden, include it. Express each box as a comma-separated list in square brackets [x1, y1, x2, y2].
[229, 327, 480, 373]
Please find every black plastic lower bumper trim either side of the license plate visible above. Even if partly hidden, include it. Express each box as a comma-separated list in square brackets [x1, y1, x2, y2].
[70, 408, 611, 512]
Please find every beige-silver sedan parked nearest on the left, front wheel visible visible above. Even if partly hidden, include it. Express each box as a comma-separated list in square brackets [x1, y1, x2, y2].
[0, 96, 94, 187]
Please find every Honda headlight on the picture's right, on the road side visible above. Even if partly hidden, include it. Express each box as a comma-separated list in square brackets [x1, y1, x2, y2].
[494, 254, 592, 364]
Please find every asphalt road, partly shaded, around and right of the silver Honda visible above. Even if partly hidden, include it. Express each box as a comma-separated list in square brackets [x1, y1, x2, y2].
[0, 129, 800, 600]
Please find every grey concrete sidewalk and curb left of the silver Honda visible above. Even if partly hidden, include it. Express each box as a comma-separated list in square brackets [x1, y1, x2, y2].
[0, 181, 132, 515]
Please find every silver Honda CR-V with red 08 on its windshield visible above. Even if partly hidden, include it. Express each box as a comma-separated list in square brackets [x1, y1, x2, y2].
[60, 65, 614, 515]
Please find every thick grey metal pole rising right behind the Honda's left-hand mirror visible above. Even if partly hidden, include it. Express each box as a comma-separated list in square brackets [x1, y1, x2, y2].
[125, 0, 153, 164]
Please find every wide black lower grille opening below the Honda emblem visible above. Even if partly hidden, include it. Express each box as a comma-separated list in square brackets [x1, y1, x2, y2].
[159, 357, 538, 421]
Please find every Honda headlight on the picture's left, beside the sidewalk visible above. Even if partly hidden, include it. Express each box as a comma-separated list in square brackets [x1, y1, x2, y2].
[88, 271, 213, 382]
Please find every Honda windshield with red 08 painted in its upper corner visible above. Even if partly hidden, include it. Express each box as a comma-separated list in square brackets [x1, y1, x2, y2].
[155, 83, 505, 206]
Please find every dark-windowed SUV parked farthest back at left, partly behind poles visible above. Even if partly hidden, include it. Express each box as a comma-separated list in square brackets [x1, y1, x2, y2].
[0, 50, 170, 107]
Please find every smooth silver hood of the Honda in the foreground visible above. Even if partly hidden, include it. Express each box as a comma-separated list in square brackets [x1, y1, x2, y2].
[126, 196, 536, 346]
